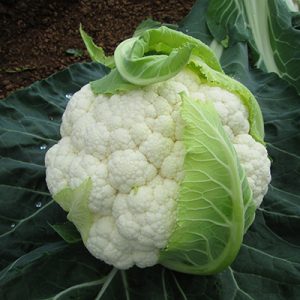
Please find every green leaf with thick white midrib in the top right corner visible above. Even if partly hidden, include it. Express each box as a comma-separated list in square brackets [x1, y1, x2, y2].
[207, 0, 300, 93]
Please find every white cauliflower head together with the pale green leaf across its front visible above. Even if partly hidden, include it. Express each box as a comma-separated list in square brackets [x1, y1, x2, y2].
[45, 27, 270, 274]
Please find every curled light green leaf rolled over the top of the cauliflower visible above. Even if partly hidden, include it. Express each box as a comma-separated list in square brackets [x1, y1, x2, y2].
[103, 26, 222, 89]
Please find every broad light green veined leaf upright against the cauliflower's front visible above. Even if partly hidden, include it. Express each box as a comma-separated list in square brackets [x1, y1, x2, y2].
[159, 95, 255, 274]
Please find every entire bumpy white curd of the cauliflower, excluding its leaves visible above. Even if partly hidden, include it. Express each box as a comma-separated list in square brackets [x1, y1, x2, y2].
[46, 70, 270, 269]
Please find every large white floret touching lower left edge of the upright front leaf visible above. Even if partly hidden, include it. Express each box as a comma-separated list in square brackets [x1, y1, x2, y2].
[113, 176, 178, 248]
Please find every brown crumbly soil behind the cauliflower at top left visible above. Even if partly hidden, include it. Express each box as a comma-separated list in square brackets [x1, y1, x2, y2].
[0, 0, 195, 99]
